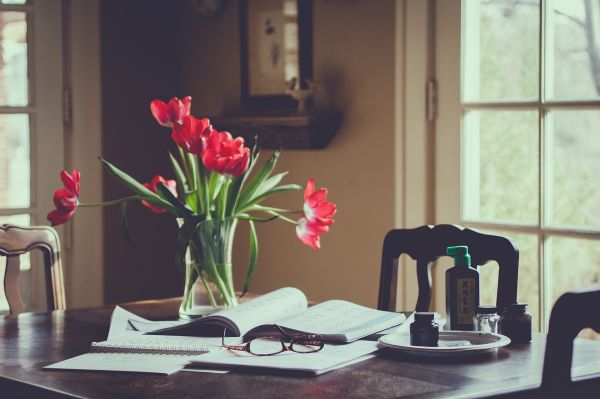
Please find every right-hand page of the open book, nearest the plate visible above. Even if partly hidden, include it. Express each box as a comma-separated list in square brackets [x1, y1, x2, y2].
[279, 300, 405, 338]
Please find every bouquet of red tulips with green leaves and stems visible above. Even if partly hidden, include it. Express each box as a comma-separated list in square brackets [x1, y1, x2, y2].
[48, 97, 336, 315]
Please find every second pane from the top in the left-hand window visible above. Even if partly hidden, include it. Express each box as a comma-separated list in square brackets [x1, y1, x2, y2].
[0, 114, 31, 208]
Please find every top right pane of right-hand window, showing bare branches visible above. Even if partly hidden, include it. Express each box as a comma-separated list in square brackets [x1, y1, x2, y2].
[546, 0, 600, 98]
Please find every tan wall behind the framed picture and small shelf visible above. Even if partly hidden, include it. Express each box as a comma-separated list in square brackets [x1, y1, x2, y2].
[182, 0, 398, 306]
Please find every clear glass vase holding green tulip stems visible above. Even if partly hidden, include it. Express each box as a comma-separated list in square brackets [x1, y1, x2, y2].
[179, 218, 238, 319]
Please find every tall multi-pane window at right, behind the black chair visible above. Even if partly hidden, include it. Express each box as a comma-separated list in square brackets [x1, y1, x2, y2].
[460, 0, 600, 338]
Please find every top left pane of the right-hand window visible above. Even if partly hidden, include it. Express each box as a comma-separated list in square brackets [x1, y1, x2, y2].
[463, 0, 540, 101]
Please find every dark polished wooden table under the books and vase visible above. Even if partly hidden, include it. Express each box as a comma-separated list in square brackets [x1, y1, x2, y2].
[0, 299, 600, 399]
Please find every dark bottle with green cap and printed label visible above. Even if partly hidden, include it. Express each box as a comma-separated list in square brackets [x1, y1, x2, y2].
[446, 246, 479, 331]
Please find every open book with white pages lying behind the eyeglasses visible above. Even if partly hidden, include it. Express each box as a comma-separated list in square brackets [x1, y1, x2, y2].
[139, 287, 406, 343]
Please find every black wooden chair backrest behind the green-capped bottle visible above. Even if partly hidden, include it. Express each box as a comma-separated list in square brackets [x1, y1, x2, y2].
[378, 224, 519, 312]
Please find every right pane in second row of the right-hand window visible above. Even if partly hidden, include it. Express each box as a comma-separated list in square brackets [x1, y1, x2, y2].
[546, 110, 600, 228]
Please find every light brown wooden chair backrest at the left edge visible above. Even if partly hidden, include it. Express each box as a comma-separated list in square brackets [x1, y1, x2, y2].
[0, 224, 65, 314]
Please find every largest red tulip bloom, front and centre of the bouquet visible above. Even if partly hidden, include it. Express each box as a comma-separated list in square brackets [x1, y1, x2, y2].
[202, 130, 250, 177]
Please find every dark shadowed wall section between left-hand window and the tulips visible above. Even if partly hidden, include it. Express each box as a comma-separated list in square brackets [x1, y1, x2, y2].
[100, 0, 187, 303]
